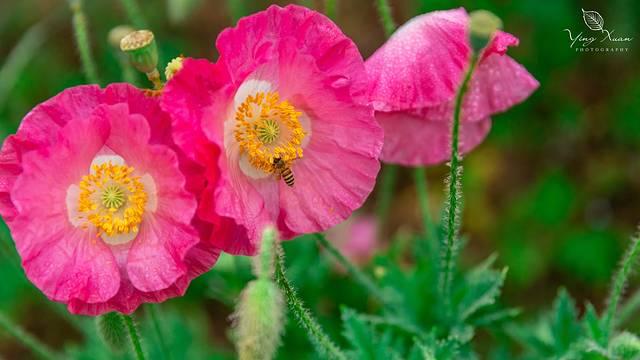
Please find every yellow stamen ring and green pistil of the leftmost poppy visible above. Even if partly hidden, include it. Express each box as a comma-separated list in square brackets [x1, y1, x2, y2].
[78, 162, 148, 236]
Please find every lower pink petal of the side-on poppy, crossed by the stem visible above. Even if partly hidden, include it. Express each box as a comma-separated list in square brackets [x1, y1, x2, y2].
[377, 112, 491, 166]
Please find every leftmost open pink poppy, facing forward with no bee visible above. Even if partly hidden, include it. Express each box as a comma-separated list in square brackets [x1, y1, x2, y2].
[0, 84, 218, 315]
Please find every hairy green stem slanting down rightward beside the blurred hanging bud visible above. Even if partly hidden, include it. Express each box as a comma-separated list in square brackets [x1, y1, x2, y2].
[275, 245, 347, 360]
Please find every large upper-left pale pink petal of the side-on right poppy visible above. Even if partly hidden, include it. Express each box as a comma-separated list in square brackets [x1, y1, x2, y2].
[365, 8, 470, 111]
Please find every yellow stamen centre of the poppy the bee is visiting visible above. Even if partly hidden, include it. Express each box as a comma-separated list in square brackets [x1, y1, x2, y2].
[234, 92, 306, 173]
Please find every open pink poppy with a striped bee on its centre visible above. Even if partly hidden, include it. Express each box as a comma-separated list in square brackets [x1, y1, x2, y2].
[161, 5, 383, 254]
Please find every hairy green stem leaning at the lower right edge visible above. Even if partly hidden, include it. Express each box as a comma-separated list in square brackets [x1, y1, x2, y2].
[604, 235, 640, 340]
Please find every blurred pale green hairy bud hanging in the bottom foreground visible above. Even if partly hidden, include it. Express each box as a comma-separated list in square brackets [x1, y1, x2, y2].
[232, 227, 285, 360]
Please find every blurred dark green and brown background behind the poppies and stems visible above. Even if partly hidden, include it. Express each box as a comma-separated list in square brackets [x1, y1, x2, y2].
[0, 0, 640, 359]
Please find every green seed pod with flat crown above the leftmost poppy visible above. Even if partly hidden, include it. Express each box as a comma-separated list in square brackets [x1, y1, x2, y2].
[120, 30, 158, 74]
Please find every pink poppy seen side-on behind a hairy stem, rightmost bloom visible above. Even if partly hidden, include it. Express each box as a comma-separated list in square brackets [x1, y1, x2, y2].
[365, 8, 539, 166]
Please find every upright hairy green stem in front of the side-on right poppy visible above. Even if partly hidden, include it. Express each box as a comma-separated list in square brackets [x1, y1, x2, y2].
[440, 54, 477, 307]
